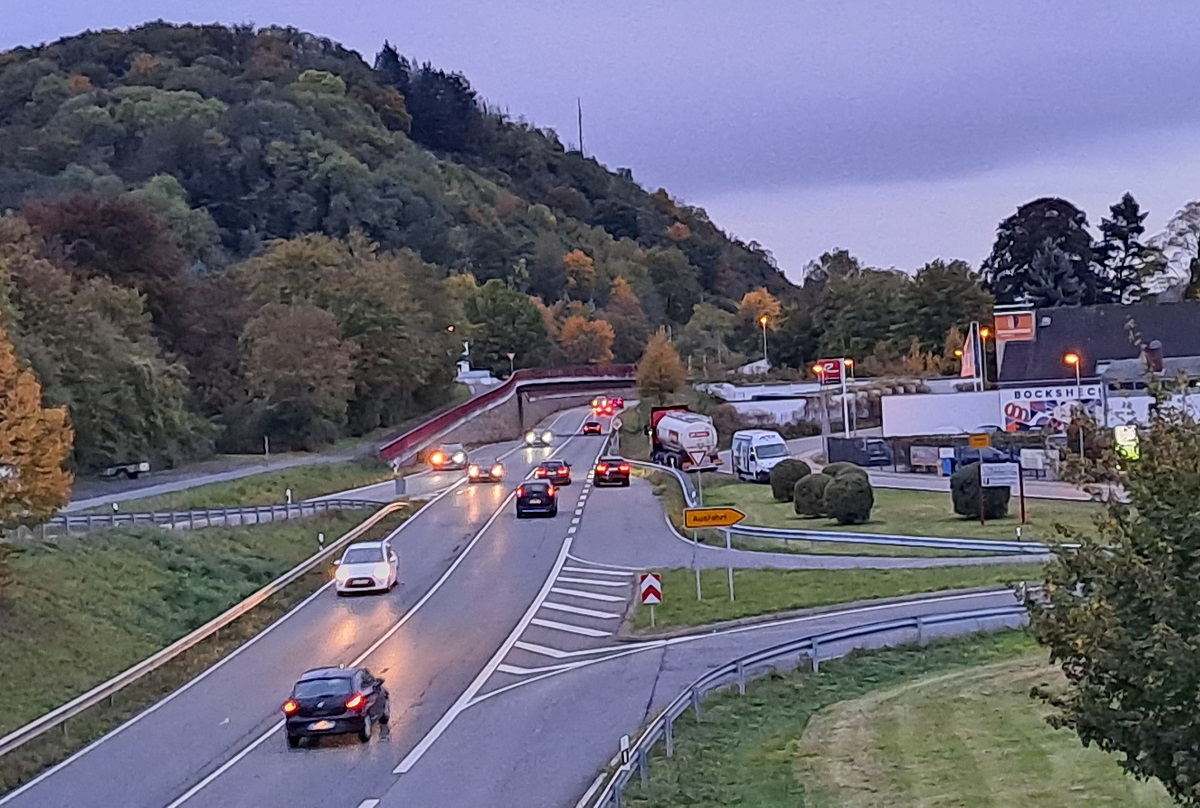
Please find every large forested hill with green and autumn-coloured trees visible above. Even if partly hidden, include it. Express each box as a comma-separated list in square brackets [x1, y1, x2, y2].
[0, 23, 790, 467]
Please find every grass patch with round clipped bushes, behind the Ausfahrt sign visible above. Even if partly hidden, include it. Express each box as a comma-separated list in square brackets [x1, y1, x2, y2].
[704, 483, 1103, 541]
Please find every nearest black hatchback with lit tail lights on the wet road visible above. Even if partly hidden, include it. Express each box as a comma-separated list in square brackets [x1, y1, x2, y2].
[283, 668, 391, 749]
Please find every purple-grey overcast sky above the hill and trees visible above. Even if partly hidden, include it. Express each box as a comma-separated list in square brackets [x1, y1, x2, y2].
[7, 0, 1200, 279]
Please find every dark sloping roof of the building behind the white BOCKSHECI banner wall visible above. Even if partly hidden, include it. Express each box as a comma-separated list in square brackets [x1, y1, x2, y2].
[997, 301, 1200, 389]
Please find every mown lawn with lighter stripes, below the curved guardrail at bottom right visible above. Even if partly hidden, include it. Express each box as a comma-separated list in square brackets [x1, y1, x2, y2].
[625, 632, 1171, 808]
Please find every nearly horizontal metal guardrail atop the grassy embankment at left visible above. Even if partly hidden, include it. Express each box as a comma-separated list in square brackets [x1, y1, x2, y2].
[40, 498, 380, 538]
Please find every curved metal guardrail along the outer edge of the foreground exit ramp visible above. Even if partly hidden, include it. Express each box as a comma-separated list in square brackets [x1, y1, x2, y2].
[585, 605, 1025, 808]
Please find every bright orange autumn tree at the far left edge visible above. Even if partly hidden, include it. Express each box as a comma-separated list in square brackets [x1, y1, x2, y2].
[0, 314, 74, 528]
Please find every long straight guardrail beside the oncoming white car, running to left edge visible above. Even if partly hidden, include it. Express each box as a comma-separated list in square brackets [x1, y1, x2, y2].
[0, 502, 408, 756]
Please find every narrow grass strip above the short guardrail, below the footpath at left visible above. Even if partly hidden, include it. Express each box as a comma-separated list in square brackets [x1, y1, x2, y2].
[84, 457, 391, 513]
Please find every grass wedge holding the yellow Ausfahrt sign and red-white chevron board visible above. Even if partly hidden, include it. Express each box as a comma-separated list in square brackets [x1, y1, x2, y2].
[634, 564, 1042, 630]
